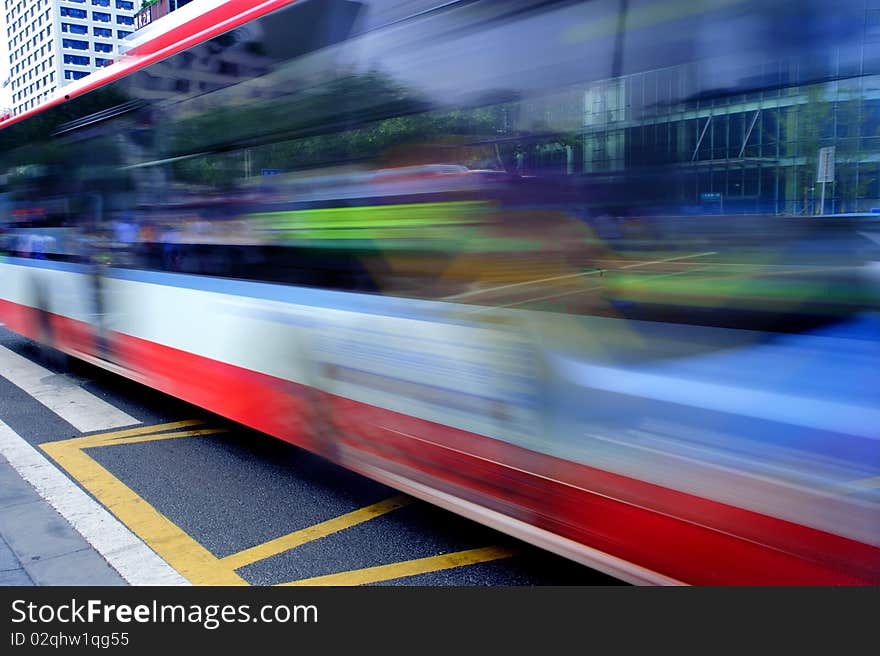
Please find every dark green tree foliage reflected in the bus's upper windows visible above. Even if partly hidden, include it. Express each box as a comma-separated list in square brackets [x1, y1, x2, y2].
[166, 72, 506, 186]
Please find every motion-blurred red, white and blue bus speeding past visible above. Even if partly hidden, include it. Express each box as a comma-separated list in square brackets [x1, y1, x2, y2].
[0, 0, 880, 585]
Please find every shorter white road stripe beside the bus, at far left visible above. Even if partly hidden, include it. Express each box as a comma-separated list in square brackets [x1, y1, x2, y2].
[0, 346, 140, 433]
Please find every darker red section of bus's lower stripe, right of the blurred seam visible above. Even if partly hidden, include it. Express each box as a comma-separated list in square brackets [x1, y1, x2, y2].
[330, 397, 880, 585]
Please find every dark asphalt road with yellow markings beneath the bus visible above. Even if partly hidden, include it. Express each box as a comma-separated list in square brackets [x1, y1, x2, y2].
[0, 328, 622, 586]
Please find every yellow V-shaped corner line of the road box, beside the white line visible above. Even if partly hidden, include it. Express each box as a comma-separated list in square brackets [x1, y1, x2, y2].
[40, 424, 248, 585]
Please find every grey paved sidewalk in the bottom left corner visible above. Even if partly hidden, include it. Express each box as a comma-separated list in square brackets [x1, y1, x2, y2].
[0, 456, 127, 586]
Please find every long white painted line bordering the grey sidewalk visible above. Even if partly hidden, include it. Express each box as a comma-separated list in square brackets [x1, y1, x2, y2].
[0, 421, 189, 586]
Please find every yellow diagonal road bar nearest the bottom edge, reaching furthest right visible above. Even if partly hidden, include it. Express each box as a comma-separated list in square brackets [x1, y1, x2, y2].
[281, 547, 516, 586]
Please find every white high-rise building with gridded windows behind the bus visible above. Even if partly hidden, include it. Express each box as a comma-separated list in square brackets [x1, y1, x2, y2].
[2, 0, 141, 114]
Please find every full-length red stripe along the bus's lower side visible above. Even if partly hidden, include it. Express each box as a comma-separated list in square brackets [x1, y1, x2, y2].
[0, 302, 880, 585]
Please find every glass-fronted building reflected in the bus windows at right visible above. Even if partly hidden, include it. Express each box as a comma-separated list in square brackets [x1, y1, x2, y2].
[579, 60, 880, 214]
